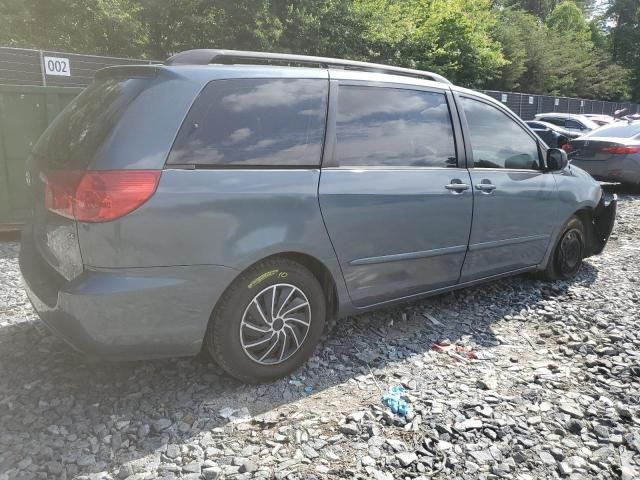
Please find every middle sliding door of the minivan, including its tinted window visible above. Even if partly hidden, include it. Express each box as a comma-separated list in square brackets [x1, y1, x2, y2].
[320, 81, 472, 306]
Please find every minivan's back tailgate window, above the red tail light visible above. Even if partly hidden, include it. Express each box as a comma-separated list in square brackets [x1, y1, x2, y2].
[34, 77, 151, 170]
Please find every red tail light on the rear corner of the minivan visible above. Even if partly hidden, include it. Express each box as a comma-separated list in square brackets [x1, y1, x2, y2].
[44, 170, 161, 222]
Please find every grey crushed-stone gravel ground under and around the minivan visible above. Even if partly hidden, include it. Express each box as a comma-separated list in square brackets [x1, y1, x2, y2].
[0, 188, 640, 480]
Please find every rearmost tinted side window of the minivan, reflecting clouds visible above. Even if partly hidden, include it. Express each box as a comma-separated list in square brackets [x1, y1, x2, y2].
[167, 79, 329, 167]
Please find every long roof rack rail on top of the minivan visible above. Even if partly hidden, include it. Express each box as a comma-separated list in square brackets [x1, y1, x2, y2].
[165, 49, 451, 85]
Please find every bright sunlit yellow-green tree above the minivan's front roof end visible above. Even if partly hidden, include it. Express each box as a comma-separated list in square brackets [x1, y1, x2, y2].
[355, 0, 505, 87]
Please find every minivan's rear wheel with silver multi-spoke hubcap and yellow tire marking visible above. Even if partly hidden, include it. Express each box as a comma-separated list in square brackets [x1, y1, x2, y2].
[205, 258, 327, 383]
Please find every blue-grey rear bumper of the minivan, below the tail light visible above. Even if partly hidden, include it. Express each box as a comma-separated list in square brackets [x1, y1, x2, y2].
[20, 228, 237, 360]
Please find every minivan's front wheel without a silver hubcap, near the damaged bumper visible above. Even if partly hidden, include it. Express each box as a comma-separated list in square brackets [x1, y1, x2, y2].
[541, 216, 586, 281]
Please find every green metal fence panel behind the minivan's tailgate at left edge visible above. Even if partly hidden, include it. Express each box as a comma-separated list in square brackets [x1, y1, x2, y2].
[0, 85, 82, 227]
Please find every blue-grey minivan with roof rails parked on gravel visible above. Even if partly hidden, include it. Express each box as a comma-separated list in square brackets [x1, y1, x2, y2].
[20, 50, 616, 382]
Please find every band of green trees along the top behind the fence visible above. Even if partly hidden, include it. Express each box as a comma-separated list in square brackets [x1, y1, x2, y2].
[0, 0, 640, 100]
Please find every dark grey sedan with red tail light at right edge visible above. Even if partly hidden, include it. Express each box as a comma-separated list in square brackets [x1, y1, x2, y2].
[569, 122, 640, 187]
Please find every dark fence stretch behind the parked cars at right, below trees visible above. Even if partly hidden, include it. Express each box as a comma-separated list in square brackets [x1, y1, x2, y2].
[480, 90, 640, 120]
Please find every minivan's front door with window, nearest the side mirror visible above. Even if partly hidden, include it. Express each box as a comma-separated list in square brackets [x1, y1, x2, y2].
[458, 96, 558, 282]
